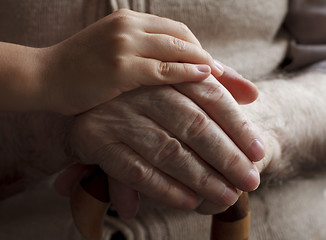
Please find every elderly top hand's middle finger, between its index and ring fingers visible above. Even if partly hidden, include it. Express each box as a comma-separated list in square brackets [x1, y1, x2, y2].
[143, 86, 259, 191]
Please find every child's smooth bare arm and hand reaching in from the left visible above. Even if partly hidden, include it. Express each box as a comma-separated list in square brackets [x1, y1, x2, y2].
[0, 9, 223, 115]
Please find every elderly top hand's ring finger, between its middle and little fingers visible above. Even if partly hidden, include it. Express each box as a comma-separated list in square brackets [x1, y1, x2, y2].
[119, 112, 238, 206]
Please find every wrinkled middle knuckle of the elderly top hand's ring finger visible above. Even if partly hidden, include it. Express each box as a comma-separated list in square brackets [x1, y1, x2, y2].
[153, 139, 183, 166]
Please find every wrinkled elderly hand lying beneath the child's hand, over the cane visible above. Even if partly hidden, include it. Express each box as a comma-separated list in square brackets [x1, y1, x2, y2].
[55, 69, 264, 217]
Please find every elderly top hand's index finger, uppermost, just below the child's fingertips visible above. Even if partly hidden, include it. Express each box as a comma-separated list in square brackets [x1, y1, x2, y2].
[175, 76, 265, 161]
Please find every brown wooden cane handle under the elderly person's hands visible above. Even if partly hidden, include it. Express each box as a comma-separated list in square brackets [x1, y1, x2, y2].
[70, 168, 250, 240]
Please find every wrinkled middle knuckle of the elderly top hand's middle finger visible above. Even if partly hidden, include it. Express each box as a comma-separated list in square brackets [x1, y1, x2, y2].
[186, 112, 210, 138]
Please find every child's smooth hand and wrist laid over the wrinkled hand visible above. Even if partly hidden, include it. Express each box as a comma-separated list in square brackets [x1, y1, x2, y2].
[43, 10, 223, 114]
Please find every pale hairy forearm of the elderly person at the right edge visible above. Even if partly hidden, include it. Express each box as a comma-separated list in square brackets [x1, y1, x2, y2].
[243, 73, 326, 179]
